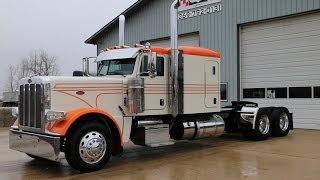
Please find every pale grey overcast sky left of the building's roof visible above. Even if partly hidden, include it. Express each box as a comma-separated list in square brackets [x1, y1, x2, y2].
[0, 0, 136, 96]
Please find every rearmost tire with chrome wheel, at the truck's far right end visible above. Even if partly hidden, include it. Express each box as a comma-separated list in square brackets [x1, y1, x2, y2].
[272, 107, 291, 137]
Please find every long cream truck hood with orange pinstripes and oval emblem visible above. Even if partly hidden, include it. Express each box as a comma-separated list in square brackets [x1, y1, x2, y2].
[20, 76, 126, 112]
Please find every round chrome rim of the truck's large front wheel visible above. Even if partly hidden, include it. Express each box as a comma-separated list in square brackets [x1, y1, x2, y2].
[79, 131, 107, 164]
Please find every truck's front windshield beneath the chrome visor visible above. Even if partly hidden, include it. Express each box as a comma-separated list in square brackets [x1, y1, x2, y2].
[98, 58, 136, 76]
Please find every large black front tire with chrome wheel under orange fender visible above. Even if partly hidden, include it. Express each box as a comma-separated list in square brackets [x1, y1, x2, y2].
[65, 123, 113, 172]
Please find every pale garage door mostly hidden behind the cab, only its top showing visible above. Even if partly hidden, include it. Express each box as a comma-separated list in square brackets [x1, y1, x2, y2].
[142, 33, 200, 47]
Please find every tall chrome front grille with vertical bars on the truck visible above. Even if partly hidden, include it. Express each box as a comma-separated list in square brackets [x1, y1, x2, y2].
[19, 84, 44, 131]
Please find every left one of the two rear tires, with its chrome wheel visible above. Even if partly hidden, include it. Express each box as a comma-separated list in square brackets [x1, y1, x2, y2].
[251, 109, 272, 141]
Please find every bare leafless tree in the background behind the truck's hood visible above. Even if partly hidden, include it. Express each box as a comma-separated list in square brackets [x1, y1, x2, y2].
[6, 50, 60, 92]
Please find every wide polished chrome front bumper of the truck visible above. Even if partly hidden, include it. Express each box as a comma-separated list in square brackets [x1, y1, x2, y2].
[9, 129, 60, 161]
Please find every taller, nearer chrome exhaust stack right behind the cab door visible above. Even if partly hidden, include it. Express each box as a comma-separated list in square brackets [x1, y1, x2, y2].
[170, 0, 179, 118]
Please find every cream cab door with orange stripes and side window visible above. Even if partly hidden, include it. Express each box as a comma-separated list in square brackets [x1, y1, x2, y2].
[140, 55, 169, 114]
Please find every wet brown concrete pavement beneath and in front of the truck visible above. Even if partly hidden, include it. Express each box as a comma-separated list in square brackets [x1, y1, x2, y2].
[0, 128, 320, 180]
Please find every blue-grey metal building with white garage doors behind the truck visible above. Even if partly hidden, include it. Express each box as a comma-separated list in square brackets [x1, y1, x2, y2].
[86, 0, 320, 129]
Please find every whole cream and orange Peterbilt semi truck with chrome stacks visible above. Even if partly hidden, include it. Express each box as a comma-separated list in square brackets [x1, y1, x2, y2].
[9, 0, 293, 172]
